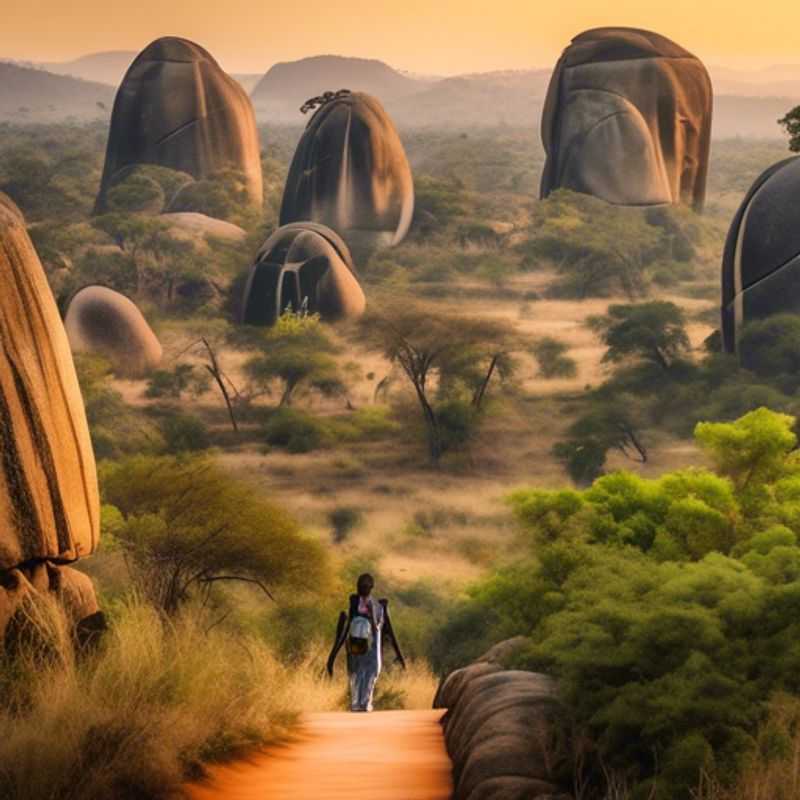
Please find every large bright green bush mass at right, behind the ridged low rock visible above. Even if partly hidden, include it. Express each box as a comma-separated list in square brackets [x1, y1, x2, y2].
[433, 409, 800, 800]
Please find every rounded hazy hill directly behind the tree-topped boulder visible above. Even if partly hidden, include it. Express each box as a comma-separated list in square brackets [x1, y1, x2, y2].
[251, 56, 418, 121]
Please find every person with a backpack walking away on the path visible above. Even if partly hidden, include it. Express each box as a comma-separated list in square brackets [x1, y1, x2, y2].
[328, 573, 406, 711]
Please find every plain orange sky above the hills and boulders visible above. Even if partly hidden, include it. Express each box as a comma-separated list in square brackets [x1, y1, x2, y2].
[0, 0, 800, 74]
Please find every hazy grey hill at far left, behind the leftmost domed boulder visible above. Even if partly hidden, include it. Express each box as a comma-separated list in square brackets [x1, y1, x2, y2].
[0, 63, 115, 122]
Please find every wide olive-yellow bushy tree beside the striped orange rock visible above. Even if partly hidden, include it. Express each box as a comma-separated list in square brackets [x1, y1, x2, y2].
[101, 456, 326, 613]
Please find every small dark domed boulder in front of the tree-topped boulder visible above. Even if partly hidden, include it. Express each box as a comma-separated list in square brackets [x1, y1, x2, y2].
[241, 222, 366, 325]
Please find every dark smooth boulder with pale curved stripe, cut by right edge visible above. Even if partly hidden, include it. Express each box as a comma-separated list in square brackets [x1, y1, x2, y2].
[722, 156, 800, 353]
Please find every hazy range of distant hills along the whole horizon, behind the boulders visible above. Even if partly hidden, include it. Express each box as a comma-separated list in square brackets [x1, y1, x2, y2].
[0, 51, 800, 139]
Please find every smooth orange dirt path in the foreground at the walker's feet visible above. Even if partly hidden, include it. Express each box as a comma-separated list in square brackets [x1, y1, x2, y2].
[184, 711, 452, 800]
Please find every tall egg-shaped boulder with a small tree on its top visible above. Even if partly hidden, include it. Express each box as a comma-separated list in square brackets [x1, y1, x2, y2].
[280, 90, 414, 258]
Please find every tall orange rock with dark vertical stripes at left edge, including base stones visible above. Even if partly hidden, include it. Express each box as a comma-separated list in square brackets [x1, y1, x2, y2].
[0, 194, 100, 637]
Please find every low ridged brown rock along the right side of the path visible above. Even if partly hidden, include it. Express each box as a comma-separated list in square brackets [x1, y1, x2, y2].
[434, 651, 570, 800]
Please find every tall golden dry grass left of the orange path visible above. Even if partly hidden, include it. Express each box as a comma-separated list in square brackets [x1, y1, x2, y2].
[0, 601, 338, 800]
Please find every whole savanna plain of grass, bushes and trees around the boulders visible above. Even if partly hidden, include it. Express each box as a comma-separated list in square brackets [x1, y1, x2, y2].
[0, 115, 800, 800]
